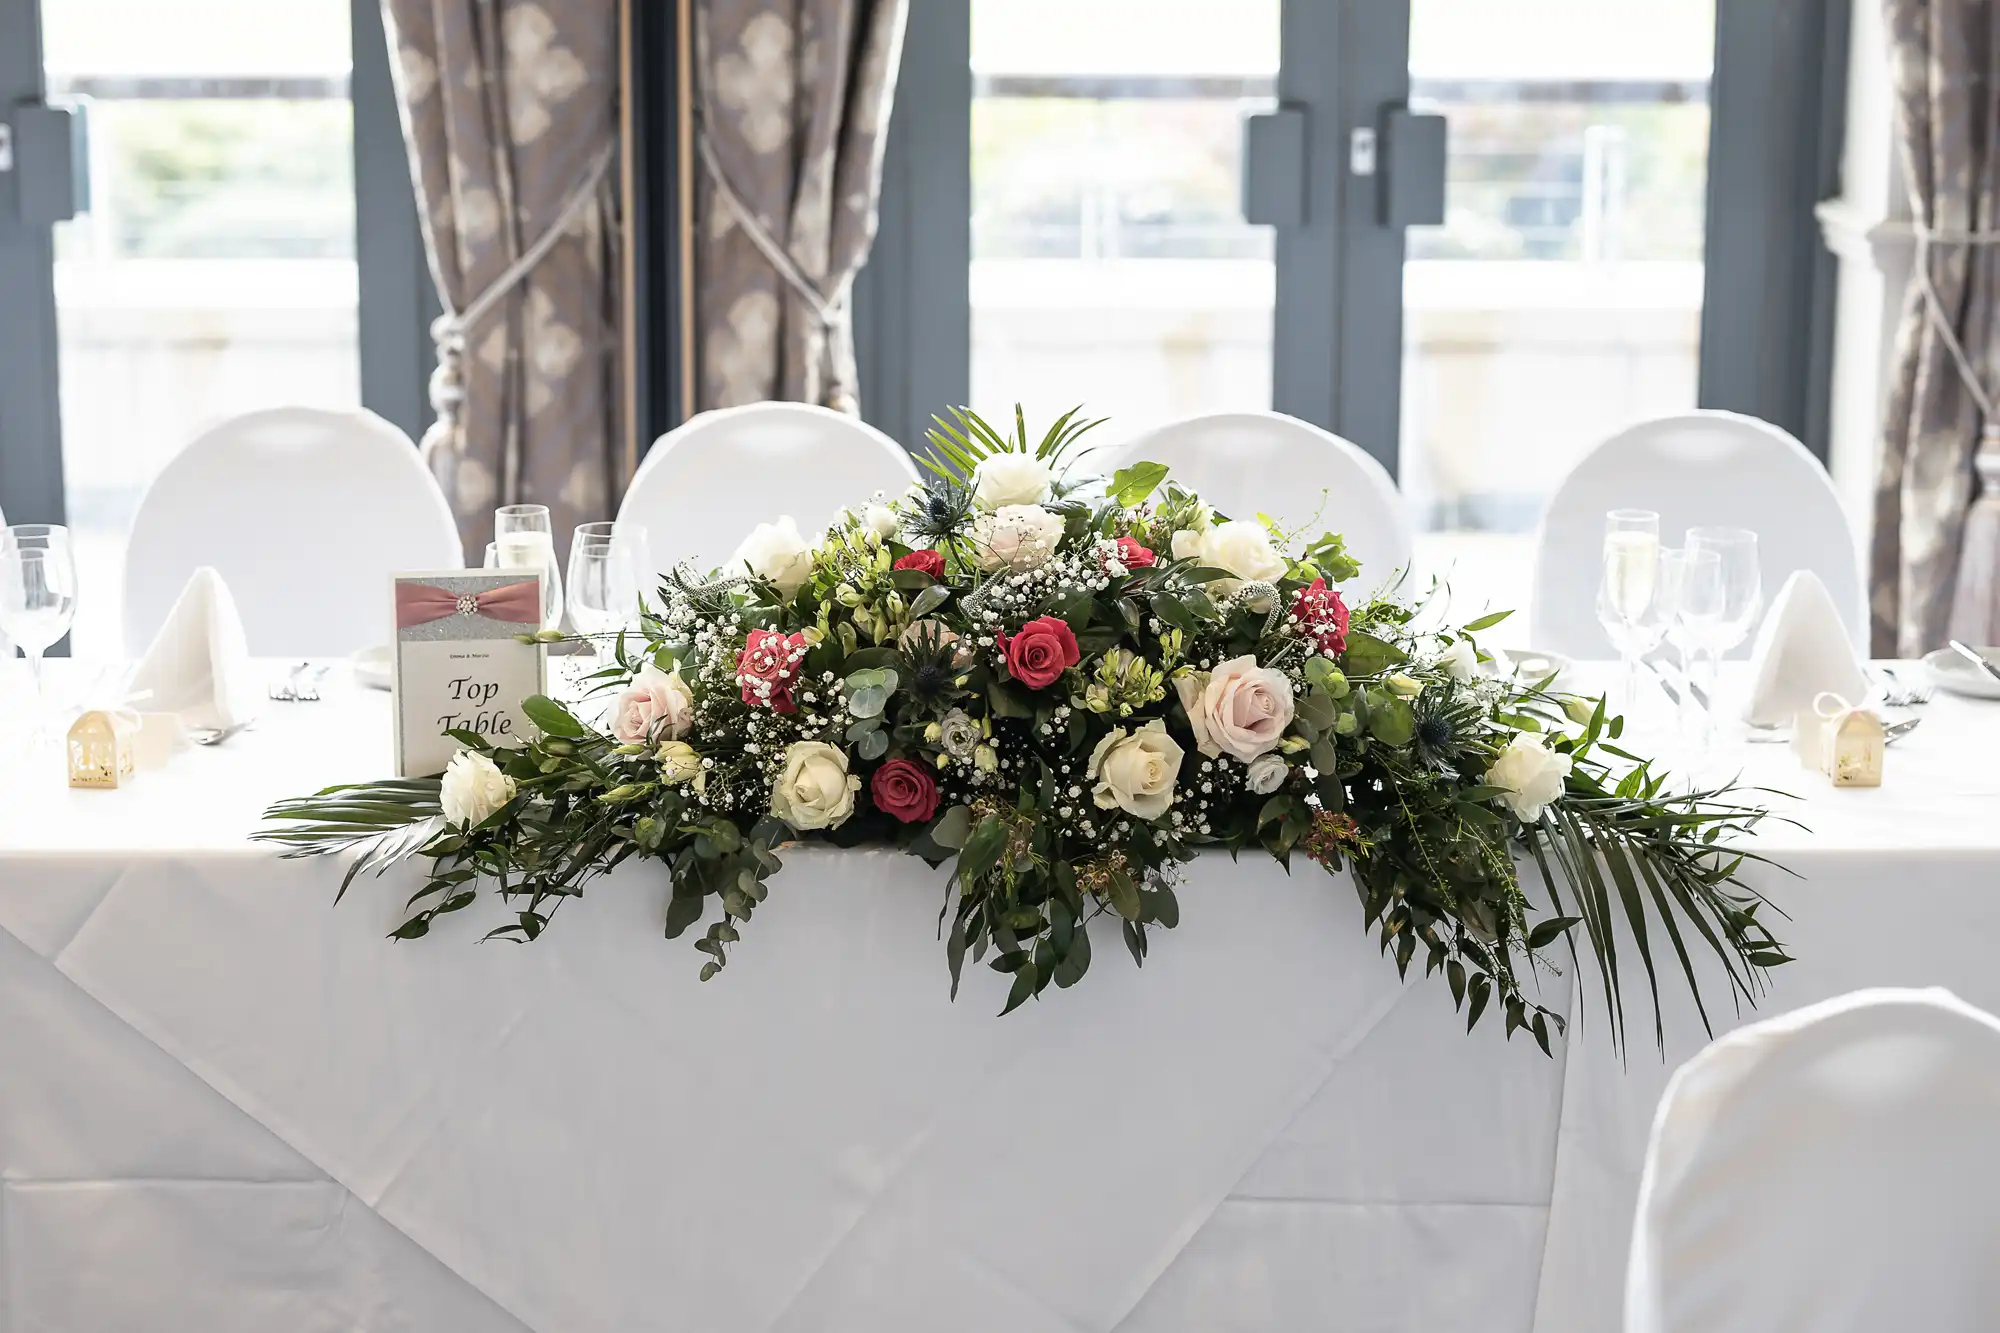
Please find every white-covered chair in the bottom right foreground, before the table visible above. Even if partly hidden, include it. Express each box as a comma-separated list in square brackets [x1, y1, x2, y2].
[1624, 989, 2000, 1333]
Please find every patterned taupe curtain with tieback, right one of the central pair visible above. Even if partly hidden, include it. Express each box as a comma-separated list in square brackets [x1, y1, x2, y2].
[694, 0, 908, 412]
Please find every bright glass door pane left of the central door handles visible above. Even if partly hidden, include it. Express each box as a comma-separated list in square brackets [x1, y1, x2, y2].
[968, 0, 1280, 444]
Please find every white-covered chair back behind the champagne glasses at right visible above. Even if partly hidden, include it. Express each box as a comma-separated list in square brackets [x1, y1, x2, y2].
[1530, 410, 1868, 656]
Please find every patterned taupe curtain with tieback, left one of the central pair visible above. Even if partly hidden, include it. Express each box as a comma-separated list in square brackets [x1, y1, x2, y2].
[382, 0, 620, 562]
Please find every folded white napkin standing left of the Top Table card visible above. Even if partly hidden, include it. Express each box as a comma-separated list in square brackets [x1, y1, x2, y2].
[128, 564, 256, 727]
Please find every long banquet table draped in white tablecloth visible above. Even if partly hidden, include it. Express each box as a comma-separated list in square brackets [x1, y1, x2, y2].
[0, 660, 2000, 1333]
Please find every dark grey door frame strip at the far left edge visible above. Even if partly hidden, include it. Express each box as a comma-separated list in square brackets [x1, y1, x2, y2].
[0, 0, 62, 522]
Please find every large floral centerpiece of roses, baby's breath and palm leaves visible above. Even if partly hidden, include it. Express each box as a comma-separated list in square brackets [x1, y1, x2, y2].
[260, 410, 1786, 1051]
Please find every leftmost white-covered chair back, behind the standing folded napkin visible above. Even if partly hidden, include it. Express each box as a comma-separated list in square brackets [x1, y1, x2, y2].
[124, 408, 464, 656]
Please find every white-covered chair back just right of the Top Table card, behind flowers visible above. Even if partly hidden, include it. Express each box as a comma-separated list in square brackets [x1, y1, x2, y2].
[618, 402, 918, 568]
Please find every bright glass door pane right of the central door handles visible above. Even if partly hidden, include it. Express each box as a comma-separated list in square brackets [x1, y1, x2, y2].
[1398, 0, 1716, 634]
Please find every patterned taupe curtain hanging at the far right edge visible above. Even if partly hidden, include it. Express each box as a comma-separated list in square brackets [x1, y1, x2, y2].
[1870, 0, 2000, 656]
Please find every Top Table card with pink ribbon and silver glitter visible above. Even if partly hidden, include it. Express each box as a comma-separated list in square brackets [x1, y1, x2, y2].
[392, 568, 548, 777]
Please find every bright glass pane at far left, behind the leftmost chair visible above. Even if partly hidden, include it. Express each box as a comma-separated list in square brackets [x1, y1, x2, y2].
[42, 0, 360, 656]
